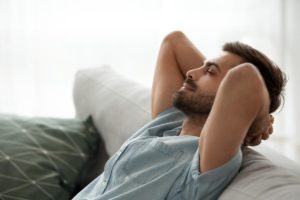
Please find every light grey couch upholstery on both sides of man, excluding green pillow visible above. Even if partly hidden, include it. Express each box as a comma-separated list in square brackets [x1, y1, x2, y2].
[74, 66, 300, 200]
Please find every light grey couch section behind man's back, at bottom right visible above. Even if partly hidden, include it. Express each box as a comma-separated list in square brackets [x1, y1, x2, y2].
[219, 148, 300, 200]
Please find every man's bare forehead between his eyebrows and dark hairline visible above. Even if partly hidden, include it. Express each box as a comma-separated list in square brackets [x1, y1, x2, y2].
[206, 51, 245, 71]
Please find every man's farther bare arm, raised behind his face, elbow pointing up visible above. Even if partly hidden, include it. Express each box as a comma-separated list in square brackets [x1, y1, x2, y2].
[151, 31, 205, 118]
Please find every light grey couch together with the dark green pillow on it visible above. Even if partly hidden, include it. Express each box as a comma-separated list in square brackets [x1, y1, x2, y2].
[0, 65, 300, 200]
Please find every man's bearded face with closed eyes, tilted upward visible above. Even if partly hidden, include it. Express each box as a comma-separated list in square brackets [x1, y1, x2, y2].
[173, 52, 244, 117]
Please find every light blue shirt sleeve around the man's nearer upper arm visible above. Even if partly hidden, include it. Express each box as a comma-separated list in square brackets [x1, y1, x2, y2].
[182, 149, 242, 199]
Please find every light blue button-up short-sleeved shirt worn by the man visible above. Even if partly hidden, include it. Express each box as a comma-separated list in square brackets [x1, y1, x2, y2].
[74, 107, 242, 200]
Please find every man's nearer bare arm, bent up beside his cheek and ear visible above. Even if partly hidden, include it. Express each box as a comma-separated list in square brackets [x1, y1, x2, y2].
[199, 63, 269, 172]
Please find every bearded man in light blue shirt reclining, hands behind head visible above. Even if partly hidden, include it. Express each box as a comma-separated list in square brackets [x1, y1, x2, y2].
[75, 31, 285, 200]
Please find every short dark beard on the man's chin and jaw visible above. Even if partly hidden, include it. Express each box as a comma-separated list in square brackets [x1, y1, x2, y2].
[173, 90, 215, 118]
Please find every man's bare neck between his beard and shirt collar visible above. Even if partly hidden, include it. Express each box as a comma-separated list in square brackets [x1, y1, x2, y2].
[179, 116, 207, 137]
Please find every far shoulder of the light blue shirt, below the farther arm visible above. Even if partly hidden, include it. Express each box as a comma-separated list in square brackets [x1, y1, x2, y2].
[130, 106, 184, 139]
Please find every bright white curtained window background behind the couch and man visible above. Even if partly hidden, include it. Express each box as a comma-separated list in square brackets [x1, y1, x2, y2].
[0, 0, 300, 161]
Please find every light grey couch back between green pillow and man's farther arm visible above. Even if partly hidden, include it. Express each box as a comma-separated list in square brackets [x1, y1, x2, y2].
[73, 65, 151, 156]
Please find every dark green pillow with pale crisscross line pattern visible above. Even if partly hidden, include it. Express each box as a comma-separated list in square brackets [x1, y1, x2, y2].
[0, 115, 98, 200]
